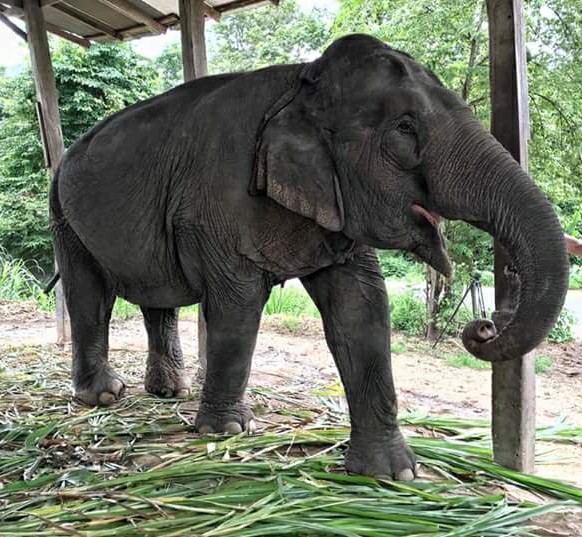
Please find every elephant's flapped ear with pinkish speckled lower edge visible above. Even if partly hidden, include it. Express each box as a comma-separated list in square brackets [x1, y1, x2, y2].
[251, 89, 344, 231]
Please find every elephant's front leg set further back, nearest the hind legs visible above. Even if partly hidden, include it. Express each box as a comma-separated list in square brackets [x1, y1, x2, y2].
[195, 290, 267, 434]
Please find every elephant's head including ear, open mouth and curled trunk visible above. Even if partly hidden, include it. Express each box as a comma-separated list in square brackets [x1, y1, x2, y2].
[254, 35, 568, 361]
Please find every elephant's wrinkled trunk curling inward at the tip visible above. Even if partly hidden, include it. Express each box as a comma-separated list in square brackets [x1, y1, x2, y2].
[424, 110, 568, 362]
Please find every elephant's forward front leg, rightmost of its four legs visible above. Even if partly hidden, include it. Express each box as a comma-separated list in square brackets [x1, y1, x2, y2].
[302, 250, 416, 480]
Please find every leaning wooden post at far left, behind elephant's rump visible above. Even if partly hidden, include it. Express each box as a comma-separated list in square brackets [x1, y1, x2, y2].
[23, 0, 70, 344]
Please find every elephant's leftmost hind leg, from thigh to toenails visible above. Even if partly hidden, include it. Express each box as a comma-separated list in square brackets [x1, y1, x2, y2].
[54, 220, 126, 406]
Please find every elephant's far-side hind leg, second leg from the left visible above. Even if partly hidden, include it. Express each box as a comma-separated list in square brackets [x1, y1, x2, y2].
[141, 307, 191, 397]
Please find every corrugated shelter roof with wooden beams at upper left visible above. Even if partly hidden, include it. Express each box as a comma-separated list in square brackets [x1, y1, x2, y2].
[0, 0, 279, 44]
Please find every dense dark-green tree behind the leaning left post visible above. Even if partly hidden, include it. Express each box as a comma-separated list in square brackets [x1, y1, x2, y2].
[0, 42, 159, 268]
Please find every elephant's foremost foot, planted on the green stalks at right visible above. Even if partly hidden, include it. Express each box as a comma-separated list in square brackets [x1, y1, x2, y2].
[345, 429, 418, 481]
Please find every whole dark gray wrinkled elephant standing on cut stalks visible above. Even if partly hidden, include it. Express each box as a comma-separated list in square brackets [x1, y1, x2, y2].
[51, 35, 567, 479]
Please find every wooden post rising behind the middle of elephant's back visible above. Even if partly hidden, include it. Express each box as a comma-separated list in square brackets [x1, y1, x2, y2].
[180, 0, 208, 372]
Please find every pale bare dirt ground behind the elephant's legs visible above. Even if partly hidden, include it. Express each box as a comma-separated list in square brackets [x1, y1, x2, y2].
[0, 303, 582, 485]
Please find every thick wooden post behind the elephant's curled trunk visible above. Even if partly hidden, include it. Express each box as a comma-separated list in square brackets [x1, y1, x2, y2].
[487, 0, 535, 472]
